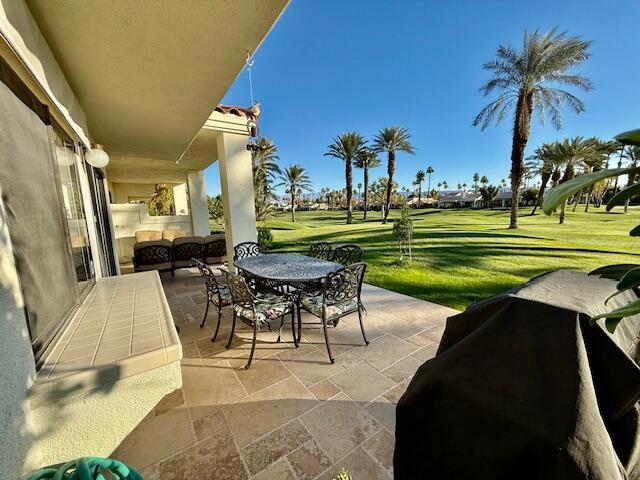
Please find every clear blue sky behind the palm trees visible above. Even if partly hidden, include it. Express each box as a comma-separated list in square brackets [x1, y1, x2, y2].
[206, 0, 640, 194]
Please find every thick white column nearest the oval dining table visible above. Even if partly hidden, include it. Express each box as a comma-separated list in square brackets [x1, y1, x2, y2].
[218, 132, 257, 264]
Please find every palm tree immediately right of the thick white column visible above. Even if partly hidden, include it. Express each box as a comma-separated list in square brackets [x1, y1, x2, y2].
[251, 137, 281, 220]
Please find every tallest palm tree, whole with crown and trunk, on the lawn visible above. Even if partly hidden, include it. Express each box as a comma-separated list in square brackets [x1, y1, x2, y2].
[473, 29, 592, 228]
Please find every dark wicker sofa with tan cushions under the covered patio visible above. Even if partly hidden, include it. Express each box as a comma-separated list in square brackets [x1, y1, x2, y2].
[133, 229, 227, 275]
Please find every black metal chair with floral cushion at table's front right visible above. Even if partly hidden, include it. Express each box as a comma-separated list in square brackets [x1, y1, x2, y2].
[298, 263, 369, 363]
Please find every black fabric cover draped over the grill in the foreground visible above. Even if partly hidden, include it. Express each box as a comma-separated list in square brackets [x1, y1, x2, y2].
[394, 270, 640, 480]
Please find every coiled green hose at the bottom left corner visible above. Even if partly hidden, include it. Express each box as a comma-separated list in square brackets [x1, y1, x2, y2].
[26, 457, 143, 480]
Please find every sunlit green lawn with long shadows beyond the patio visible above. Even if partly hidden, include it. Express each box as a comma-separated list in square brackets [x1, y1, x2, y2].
[255, 206, 640, 310]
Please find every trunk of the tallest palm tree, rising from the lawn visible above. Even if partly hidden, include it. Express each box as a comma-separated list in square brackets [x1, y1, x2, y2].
[509, 91, 533, 228]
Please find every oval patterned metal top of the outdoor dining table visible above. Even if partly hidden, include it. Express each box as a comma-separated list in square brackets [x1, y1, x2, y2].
[233, 253, 342, 284]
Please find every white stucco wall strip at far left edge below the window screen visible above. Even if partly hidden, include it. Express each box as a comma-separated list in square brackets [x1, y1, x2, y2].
[0, 190, 36, 479]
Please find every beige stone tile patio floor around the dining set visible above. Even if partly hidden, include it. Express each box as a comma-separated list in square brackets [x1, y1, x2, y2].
[113, 269, 458, 480]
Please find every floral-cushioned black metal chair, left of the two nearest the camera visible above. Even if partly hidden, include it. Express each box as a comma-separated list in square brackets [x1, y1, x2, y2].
[222, 271, 298, 369]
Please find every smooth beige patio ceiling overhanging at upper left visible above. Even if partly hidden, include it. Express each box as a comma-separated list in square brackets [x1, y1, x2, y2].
[27, 0, 288, 161]
